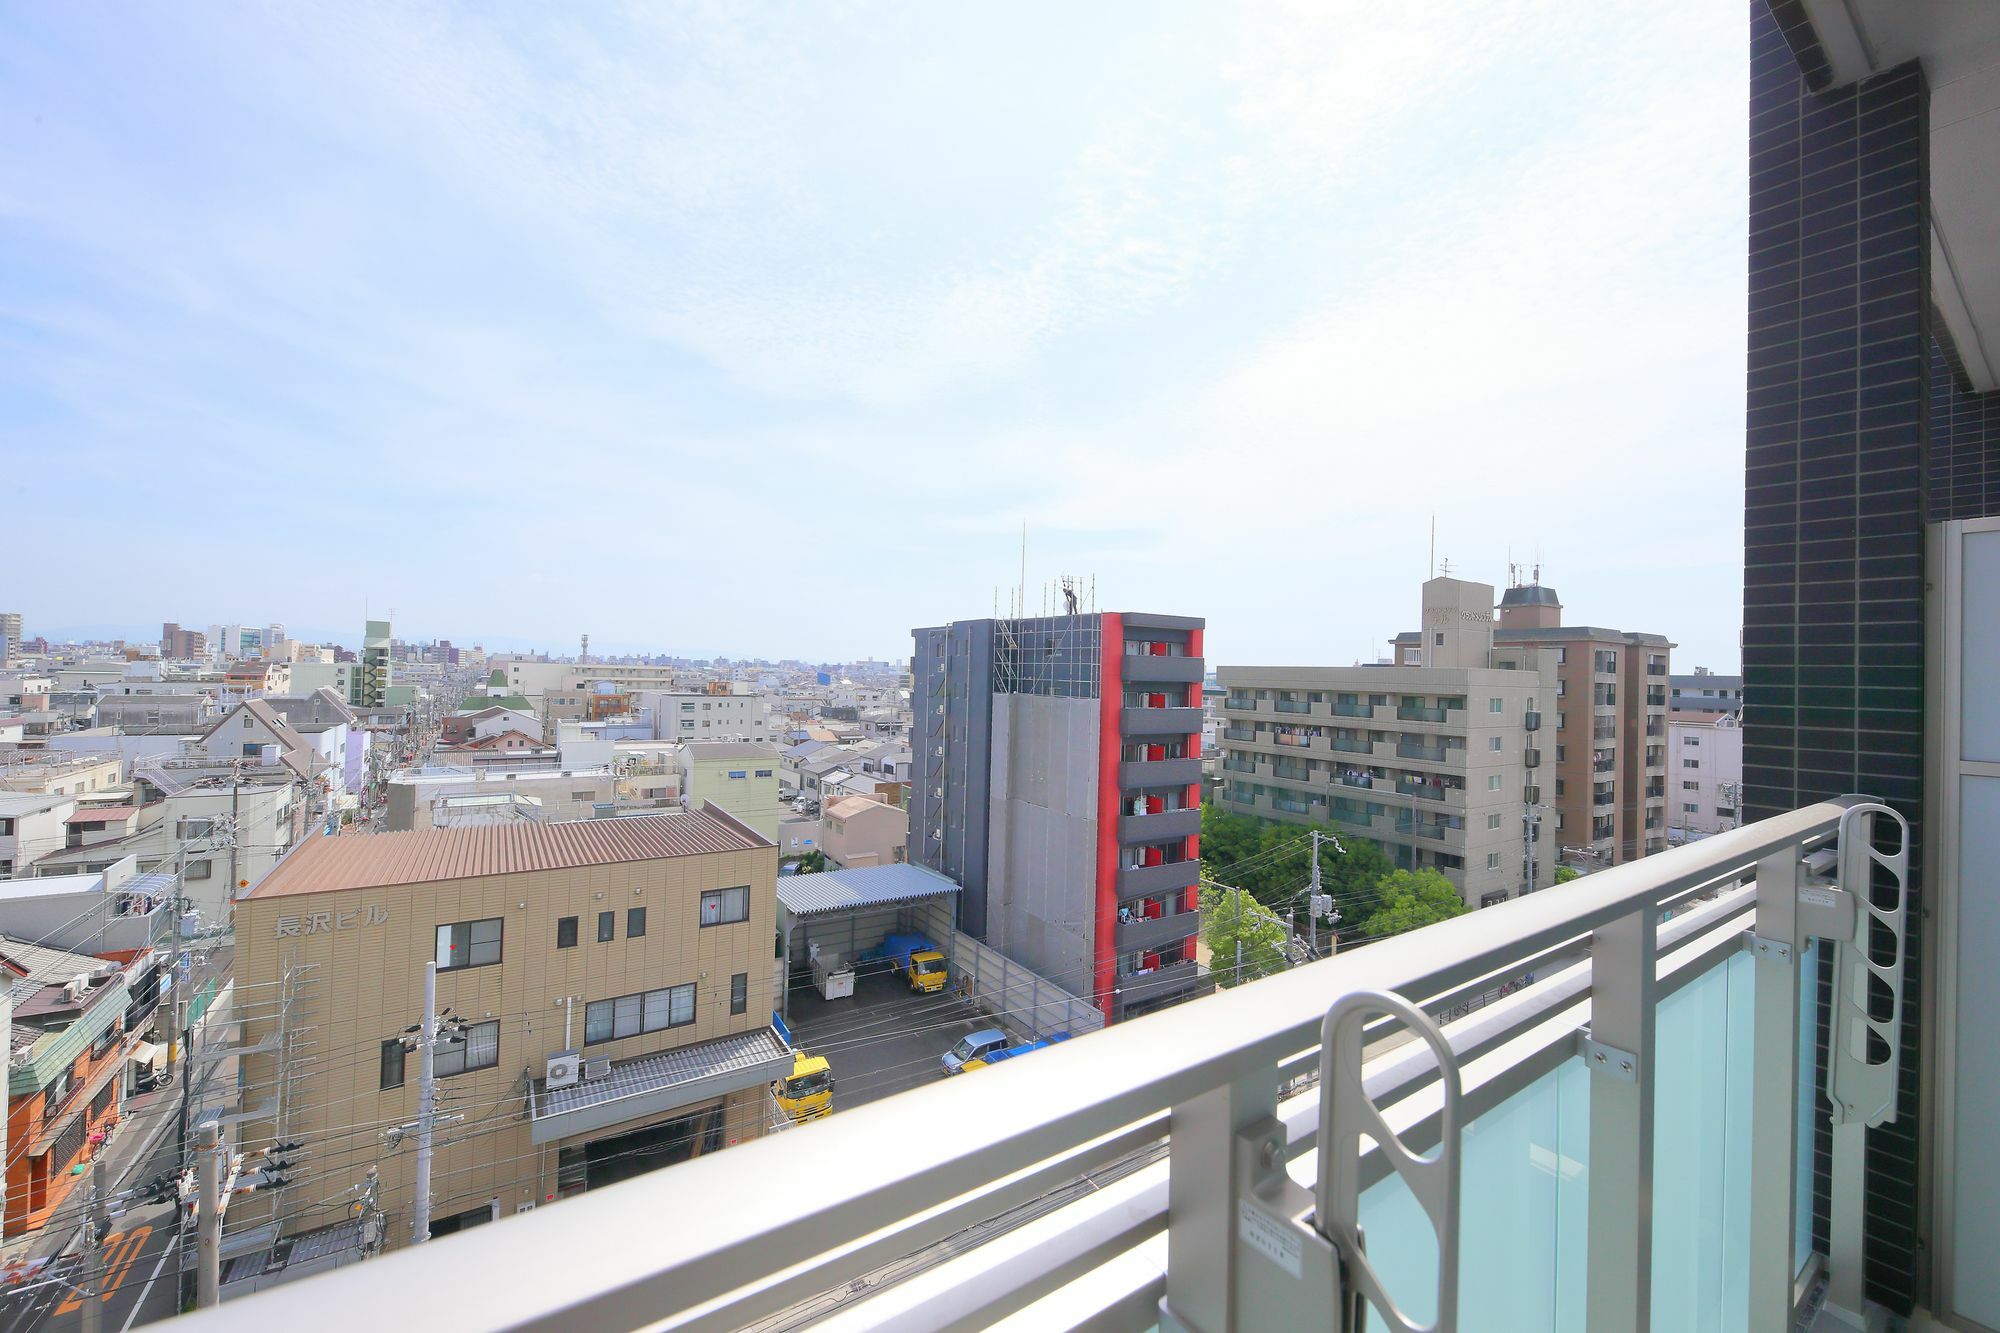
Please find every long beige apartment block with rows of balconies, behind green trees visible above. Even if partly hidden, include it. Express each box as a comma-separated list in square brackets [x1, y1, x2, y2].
[1216, 578, 1556, 907]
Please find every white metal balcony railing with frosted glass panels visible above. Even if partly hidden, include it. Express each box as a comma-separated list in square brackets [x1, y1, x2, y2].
[195, 797, 1908, 1333]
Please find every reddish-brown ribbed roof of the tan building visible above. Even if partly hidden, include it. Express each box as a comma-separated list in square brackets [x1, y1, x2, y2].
[250, 811, 770, 899]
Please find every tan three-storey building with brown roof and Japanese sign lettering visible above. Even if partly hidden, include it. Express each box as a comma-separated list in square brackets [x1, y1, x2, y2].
[230, 807, 790, 1247]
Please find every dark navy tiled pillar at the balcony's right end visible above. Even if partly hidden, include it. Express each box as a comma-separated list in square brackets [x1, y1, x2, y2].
[1744, 0, 1930, 1311]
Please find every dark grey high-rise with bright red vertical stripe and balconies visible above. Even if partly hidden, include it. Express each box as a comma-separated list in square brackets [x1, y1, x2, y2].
[910, 610, 1204, 1021]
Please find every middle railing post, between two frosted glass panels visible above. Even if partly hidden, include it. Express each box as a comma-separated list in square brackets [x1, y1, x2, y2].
[1584, 907, 1658, 1333]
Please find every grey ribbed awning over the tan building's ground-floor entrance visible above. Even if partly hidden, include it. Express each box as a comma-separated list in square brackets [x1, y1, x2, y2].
[528, 1027, 792, 1143]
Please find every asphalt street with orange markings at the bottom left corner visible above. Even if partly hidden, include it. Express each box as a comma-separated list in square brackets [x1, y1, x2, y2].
[0, 1135, 180, 1333]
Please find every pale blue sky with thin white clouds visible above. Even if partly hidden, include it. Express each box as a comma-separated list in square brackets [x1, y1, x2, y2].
[0, 0, 1748, 669]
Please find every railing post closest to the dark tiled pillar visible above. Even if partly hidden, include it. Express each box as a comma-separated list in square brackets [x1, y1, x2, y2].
[1750, 849, 1800, 1329]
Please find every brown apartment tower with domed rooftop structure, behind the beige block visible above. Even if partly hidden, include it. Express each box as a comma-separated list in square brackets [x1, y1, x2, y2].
[1396, 580, 1674, 869]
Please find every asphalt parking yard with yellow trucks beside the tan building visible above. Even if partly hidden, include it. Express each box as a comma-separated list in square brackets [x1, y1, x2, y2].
[786, 967, 1000, 1113]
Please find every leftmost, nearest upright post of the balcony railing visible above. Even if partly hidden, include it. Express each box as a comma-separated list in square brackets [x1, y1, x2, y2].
[1160, 1067, 1278, 1333]
